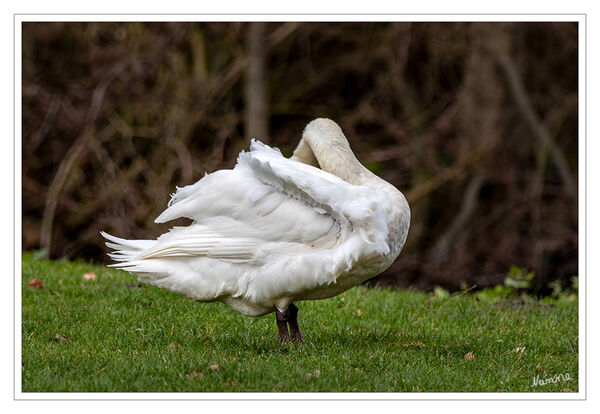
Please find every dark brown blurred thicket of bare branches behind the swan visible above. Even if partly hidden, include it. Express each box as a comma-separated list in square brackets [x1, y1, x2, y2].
[22, 22, 578, 292]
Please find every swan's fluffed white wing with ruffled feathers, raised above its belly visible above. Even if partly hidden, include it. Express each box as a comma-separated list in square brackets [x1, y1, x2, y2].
[115, 141, 389, 265]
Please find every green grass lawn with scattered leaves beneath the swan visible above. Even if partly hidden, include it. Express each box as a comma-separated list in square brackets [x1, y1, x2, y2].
[22, 254, 578, 392]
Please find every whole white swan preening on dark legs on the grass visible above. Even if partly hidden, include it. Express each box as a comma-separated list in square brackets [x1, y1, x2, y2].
[102, 118, 410, 342]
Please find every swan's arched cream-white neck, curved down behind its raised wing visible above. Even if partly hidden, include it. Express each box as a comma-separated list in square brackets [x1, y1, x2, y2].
[291, 118, 398, 191]
